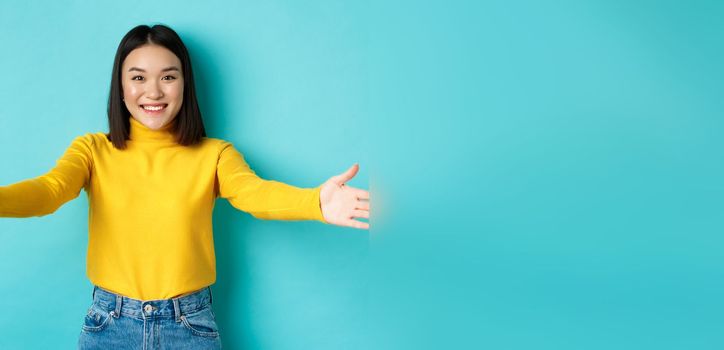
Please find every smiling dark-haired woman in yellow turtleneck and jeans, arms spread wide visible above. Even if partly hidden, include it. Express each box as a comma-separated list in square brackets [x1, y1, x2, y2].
[0, 25, 369, 349]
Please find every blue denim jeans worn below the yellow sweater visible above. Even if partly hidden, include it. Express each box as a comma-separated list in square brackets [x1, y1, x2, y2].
[78, 286, 221, 350]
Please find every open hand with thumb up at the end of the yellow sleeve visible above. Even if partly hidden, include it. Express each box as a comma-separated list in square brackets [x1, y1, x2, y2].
[319, 164, 370, 229]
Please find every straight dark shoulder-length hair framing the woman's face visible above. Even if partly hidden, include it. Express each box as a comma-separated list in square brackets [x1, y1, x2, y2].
[107, 24, 206, 149]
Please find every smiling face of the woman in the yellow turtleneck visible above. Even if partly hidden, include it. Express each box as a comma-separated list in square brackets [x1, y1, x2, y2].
[121, 44, 184, 130]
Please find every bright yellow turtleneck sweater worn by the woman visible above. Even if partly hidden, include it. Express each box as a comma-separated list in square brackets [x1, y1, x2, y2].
[0, 118, 324, 300]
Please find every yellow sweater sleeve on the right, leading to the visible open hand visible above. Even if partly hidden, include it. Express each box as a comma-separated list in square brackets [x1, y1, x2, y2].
[217, 142, 324, 222]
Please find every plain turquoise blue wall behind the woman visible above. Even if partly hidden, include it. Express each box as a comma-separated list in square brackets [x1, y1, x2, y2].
[0, 0, 724, 349]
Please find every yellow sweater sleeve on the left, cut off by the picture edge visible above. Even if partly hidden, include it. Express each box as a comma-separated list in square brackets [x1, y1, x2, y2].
[0, 135, 93, 217]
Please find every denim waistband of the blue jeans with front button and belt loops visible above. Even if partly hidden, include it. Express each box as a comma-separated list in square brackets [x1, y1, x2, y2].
[93, 286, 212, 321]
